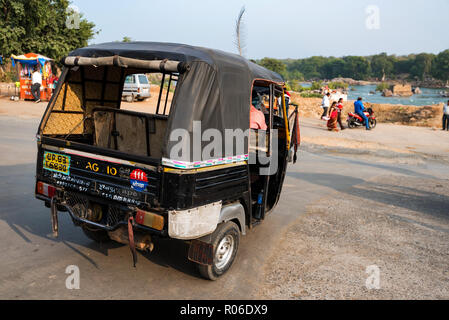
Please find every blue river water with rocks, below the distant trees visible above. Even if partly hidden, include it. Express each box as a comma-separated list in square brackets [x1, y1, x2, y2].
[348, 85, 449, 106]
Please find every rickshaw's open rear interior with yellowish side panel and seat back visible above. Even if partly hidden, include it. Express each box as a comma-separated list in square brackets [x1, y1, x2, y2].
[39, 66, 179, 158]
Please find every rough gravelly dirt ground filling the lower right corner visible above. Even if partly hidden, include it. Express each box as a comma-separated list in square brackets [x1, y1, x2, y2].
[260, 176, 449, 299]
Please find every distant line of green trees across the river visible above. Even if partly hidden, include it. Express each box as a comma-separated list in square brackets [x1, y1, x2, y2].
[256, 49, 449, 81]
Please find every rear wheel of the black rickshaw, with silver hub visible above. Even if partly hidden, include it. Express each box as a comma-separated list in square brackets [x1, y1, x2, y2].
[198, 221, 240, 281]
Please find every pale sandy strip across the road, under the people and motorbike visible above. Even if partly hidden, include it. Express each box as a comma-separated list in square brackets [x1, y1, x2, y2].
[301, 118, 449, 164]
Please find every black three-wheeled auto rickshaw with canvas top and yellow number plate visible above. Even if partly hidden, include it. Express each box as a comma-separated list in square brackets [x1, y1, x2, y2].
[36, 42, 299, 280]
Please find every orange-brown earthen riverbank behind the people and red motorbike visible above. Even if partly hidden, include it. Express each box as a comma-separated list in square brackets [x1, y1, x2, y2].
[292, 92, 443, 128]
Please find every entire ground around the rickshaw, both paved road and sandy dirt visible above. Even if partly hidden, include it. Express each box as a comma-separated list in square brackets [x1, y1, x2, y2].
[0, 99, 449, 299]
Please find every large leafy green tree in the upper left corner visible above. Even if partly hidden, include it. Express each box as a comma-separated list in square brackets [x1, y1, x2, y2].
[0, 0, 97, 61]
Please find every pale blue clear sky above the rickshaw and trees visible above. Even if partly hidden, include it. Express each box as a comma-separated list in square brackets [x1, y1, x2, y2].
[72, 0, 449, 59]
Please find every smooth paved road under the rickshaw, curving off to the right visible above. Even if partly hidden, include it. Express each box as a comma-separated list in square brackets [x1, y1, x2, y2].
[0, 117, 448, 299]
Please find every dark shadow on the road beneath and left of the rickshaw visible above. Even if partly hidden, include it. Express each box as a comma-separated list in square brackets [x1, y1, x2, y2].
[0, 163, 199, 278]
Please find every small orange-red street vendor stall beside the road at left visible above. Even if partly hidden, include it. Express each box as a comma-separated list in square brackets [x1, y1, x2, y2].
[11, 53, 55, 100]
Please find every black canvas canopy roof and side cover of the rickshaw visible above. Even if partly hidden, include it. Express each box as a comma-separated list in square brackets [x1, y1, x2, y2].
[65, 42, 284, 162]
